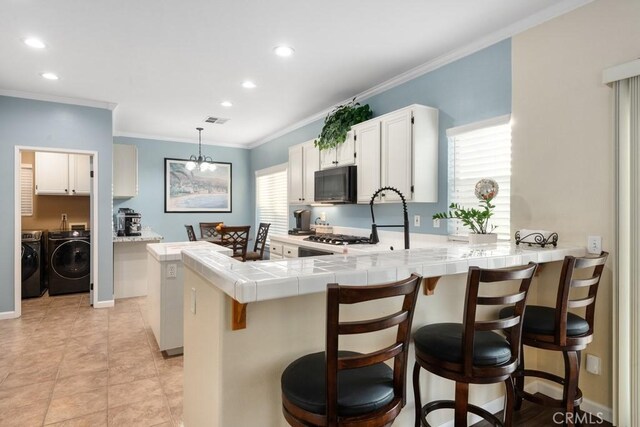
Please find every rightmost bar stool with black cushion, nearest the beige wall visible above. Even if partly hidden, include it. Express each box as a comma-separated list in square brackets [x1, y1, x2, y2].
[500, 252, 609, 425]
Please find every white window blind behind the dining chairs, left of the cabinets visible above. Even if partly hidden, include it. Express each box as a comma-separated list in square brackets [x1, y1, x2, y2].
[256, 163, 289, 242]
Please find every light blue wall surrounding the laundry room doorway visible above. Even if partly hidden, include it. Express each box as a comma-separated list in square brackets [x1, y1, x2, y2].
[0, 96, 113, 313]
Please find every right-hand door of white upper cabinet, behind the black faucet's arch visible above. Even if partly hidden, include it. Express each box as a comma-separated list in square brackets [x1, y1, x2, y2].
[382, 110, 413, 202]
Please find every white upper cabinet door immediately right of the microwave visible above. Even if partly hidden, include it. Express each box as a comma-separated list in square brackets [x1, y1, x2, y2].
[354, 121, 380, 203]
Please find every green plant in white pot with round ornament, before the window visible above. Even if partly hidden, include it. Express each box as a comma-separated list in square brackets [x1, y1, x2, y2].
[433, 178, 499, 245]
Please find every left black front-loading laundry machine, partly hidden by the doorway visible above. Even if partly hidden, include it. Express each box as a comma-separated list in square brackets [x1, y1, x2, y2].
[21, 230, 47, 299]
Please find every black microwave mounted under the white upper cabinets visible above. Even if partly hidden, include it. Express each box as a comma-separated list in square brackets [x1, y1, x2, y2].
[314, 166, 358, 203]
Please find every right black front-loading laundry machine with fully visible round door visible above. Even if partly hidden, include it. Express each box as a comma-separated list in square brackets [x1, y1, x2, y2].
[47, 230, 91, 295]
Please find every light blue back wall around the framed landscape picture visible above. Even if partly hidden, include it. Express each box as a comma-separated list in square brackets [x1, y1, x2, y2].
[113, 137, 255, 242]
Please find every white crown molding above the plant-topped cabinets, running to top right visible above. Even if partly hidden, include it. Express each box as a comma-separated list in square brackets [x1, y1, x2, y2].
[248, 0, 594, 148]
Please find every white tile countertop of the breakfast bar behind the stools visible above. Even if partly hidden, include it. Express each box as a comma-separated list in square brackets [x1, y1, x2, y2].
[182, 242, 586, 303]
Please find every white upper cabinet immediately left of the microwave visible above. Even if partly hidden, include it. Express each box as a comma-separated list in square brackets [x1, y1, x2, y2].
[287, 141, 320, 205]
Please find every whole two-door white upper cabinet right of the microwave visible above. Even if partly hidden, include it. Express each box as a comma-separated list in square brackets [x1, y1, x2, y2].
[353, 105, 438, 203]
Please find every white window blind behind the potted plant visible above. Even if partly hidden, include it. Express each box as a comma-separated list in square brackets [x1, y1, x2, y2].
[447, 116, 511, 239]
